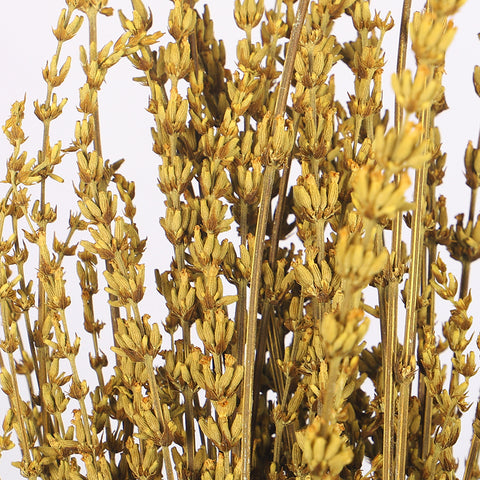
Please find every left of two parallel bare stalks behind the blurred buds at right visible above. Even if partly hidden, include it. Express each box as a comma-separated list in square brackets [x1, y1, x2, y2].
[382, 0, 412, 480]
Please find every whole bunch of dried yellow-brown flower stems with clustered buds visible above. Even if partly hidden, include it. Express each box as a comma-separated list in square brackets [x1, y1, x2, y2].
[0, 0, 480, 480]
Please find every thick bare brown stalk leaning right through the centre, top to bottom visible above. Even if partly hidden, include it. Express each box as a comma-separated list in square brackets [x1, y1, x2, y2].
[241, 0, 309, 480]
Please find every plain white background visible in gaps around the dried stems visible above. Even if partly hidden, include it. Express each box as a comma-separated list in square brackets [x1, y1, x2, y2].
[0, 0, 480, 479]
